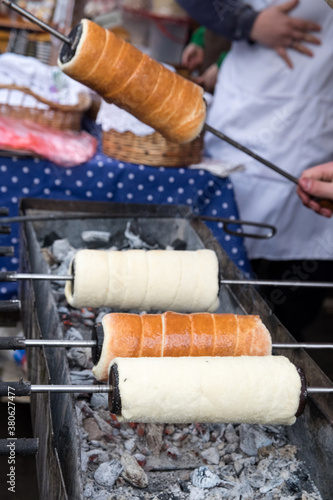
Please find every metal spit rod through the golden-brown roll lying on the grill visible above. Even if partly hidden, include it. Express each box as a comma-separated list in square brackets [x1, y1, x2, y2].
[0, 337, 333, 350]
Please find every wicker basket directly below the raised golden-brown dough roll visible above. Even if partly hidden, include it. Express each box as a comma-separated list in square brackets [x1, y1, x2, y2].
[103, 130, 203, 167]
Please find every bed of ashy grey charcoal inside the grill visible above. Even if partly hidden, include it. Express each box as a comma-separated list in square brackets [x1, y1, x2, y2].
[39, 231, 322, 500]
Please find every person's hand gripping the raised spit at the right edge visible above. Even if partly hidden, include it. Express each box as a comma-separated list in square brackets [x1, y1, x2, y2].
[297, 162, 333, 217]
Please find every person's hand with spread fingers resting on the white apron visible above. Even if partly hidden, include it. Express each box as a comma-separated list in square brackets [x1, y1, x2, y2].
[250, 0, 321, 68]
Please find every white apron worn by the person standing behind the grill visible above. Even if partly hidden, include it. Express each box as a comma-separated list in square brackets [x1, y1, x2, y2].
[206, 0, 333, 260]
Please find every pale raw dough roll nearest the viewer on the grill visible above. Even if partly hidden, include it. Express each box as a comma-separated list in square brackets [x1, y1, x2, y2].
[109, 356, 306, 425]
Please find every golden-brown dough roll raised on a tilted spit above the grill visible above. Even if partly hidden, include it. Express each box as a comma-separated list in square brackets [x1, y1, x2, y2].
[58, 19, 206, 143]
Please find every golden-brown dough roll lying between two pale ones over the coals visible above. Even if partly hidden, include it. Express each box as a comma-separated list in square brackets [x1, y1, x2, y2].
[93, 312, 272, 382]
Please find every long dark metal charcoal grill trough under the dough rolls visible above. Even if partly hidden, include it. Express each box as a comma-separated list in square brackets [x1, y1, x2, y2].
[0, 199, 333, 500]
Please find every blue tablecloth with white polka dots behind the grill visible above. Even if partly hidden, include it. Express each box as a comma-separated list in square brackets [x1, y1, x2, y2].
[0, 122, 251, 300]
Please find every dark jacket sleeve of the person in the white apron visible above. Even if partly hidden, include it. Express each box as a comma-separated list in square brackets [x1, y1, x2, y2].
[177, 0, 259, 40]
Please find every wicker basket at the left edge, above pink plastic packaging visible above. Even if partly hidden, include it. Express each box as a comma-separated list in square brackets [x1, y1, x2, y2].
[0, 85, 91, 131]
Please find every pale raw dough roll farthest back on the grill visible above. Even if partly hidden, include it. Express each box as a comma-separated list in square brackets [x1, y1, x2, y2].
[65, 250, 219, 312]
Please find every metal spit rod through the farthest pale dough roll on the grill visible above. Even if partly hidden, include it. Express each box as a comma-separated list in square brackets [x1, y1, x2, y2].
[0, 271, 333, 288]
